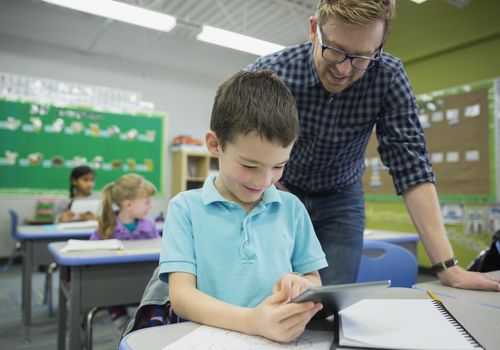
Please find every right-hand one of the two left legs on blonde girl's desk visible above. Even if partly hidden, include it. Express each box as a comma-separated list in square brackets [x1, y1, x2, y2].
[69, 266, 82, 350]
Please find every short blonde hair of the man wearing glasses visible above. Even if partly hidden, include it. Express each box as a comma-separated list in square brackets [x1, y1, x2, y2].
[316, 0, 396, 37]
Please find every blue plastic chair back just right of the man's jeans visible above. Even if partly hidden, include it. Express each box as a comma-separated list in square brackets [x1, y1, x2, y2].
[356, 240, 418, 288]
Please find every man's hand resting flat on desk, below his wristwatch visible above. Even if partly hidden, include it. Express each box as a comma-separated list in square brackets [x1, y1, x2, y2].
[438, 266, 500, 292]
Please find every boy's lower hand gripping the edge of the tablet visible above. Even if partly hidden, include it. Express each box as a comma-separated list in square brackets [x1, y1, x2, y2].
[249, 276, 323, 342]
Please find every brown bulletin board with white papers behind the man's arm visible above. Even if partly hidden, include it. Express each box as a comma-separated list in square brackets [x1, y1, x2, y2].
[363, 80, 498, 202]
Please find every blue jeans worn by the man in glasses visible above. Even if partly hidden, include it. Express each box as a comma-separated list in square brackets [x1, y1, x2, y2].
[287, 181, 365, 285]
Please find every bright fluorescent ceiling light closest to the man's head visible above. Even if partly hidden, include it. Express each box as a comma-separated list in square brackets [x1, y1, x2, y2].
[196, 25, 284, 56]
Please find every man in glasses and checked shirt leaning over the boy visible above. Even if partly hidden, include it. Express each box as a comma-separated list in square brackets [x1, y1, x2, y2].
[248, 0, 500, 291]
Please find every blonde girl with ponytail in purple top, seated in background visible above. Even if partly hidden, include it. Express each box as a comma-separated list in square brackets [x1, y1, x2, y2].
[90, 174, 160, 331]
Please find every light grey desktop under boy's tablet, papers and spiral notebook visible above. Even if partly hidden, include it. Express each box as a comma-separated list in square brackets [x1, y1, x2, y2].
[119, 288, 500, 350]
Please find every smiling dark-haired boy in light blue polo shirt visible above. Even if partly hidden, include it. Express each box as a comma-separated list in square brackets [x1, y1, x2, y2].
[160, 70, 327, 342]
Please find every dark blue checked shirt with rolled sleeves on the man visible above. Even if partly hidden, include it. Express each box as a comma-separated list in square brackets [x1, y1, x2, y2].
[247, 43, 435, 194]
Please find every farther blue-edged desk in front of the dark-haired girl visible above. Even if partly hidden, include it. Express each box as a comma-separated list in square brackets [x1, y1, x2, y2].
[17, 225, 95, 341]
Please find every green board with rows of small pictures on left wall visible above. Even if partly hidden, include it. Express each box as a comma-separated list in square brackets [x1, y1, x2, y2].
[0, 99, 165, 194]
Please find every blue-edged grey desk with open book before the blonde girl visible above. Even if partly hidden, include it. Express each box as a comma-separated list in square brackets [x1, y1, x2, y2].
[49, 239, 161, 350]
